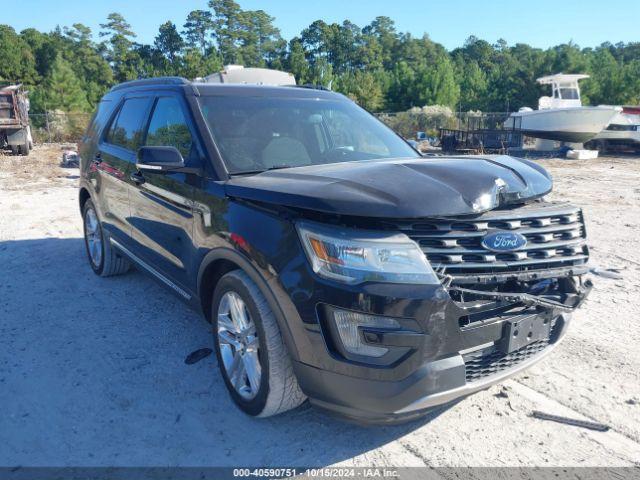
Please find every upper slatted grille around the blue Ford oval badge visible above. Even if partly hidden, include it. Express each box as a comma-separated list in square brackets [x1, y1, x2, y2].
[399, 202, 589, 276]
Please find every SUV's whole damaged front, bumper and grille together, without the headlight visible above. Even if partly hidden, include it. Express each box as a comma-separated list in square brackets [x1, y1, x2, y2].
[268, 195, 592, 422]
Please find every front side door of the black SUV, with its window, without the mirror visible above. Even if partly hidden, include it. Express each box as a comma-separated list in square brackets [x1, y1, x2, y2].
[131, 93, 202, 297]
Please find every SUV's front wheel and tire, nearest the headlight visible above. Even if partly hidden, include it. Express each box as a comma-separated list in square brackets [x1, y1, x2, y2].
[212, 270, 306, 417]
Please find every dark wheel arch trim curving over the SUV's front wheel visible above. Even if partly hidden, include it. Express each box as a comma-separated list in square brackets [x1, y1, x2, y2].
[198, 248, 300, 360]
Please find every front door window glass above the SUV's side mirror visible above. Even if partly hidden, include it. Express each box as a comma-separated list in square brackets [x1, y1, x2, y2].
[146, 97, 193, 159]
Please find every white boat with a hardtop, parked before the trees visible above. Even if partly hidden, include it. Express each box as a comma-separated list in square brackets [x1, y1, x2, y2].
[504, 73, 622, 143]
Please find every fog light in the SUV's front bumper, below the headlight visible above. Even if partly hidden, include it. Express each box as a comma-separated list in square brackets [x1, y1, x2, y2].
[333, 310, 401, 357]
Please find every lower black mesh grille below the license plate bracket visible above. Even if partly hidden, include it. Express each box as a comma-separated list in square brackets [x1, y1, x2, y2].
[463, 340, 549, 382]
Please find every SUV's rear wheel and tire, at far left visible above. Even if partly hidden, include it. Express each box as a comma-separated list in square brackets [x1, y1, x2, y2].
[82, 200, 131, 277]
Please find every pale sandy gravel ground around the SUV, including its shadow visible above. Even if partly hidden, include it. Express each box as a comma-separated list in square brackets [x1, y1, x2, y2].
[0, 146, 640, 466]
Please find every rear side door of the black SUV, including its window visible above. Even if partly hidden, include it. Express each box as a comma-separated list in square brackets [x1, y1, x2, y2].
[91, 96, 151, 243]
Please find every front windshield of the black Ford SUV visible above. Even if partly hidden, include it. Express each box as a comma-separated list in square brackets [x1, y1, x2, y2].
[199, 95, 419, 174]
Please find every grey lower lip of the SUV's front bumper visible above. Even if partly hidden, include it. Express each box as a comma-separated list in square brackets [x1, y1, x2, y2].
[294, 308, 571, 423]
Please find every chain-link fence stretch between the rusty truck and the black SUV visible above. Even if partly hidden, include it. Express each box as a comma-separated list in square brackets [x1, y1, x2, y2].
[29, 112, 91, 143]
